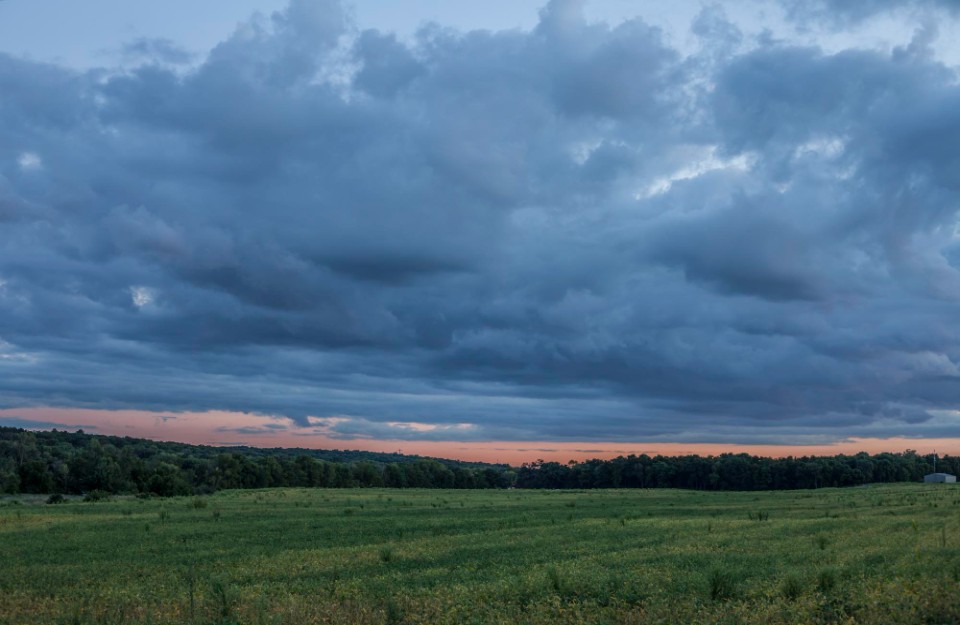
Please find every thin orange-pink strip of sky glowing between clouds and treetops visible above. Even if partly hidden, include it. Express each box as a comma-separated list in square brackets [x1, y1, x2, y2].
[0, 408, 960, 466]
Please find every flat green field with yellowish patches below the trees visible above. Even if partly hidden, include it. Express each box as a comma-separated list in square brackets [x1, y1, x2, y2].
[0, 484, 960, 624]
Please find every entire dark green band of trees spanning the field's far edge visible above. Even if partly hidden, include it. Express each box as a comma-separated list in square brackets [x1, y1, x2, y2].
[0, 427, 948, 496]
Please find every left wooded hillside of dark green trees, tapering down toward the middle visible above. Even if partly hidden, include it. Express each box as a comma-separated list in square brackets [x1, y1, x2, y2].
[0, 427, 514, 496]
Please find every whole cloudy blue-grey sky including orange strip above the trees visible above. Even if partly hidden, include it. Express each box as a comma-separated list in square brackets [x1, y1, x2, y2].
[0, 0, 960, 463]
